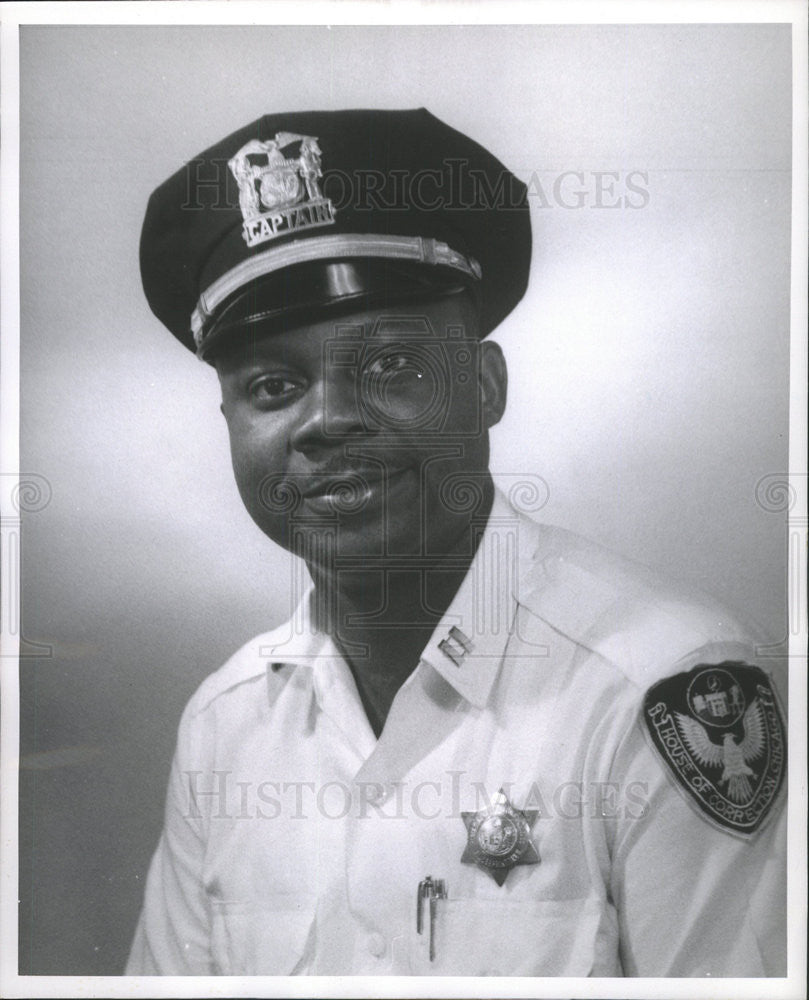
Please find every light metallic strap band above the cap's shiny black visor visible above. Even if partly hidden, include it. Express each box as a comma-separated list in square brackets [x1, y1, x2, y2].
[191, 233, 482, 349]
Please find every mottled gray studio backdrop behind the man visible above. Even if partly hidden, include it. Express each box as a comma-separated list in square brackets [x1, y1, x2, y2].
[20, 25, 791, 974]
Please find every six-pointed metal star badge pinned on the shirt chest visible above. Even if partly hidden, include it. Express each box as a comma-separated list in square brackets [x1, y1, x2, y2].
[461, 788, 539, 885]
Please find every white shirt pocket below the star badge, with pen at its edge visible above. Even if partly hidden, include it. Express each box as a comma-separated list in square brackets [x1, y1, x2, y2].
[426, 897, 614, 976]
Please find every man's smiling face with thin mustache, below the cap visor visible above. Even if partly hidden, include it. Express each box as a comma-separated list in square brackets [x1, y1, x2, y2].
[216, 296, 506, 562]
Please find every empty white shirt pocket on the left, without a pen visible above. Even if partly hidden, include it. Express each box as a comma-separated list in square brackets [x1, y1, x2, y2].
[211, 893, 317, 976]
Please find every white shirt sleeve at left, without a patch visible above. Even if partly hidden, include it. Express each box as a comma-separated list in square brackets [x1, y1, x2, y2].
[126, 700, 212, 976]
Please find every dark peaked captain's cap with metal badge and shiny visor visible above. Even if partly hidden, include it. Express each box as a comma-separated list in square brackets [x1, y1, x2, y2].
[140, 108, 531, 360]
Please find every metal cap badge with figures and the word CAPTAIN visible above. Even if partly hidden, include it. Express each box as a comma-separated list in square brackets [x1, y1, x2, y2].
[228, 132, 335, 247]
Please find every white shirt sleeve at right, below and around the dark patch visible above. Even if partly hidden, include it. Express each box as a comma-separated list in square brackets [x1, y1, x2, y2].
[610, 704, 787, 978]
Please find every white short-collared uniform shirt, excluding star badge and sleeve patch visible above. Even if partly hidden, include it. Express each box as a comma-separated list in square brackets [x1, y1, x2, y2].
[127, 495, 786, 977]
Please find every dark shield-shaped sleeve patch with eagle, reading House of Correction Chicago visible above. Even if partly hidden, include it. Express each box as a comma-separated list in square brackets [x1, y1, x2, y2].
[643, 661, 786, 836]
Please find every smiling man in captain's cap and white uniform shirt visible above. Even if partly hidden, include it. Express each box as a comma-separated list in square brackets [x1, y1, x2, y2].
[128, 110, 786, 977]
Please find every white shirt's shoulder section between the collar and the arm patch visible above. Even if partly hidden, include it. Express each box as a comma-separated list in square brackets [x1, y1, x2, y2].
[518, 525, 757, 690]
